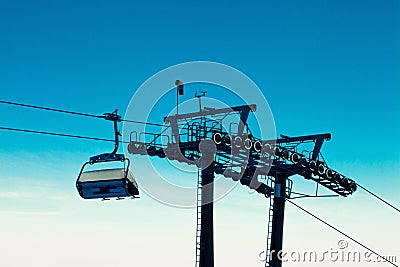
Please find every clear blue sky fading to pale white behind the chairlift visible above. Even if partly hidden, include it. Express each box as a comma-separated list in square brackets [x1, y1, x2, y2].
[0, 0, 400, 266]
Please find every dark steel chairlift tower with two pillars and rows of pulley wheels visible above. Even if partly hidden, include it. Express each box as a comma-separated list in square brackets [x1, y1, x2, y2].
[128, 101, 357, 267]
